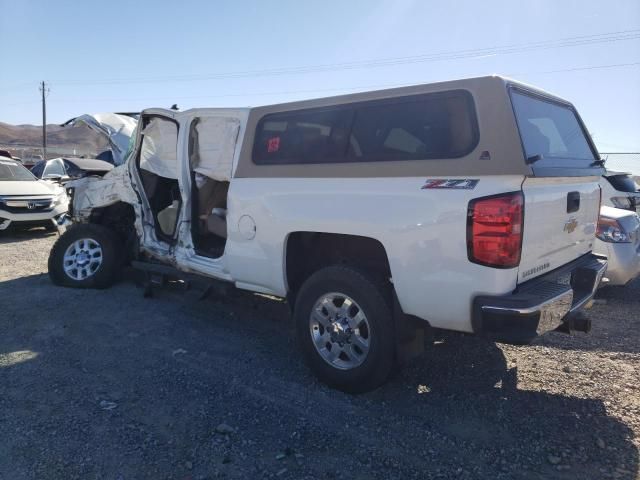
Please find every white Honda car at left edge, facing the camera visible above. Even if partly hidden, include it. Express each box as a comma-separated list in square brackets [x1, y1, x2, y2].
[0, 157, 69, 230]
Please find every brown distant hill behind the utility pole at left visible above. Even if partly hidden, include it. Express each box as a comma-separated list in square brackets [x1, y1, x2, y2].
[0, 122, 108, 156]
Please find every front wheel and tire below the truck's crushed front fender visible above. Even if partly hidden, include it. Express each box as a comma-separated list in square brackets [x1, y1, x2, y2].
[49, 224, 123, 288]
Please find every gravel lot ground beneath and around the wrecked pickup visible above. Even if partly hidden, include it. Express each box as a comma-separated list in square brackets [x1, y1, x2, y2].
[0, 230, 640, 480]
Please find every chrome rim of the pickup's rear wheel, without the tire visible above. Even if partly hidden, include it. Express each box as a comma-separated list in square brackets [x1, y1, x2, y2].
[309, 292, 371, 370]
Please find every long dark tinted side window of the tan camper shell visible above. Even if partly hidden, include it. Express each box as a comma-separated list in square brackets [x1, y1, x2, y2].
[253, 90, 478, 165]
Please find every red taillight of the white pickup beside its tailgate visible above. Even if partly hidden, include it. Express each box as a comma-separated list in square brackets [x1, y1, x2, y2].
[467, 192, 524, 268]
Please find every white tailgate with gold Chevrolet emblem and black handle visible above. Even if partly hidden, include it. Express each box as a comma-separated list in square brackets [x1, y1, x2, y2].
[518, 177, 600, 283]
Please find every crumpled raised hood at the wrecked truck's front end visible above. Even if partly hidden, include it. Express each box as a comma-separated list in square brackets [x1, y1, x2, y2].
[62, 113, 138, 166]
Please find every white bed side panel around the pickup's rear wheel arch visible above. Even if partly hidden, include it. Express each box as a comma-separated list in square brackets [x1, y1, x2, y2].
[225, 175, 523, 332]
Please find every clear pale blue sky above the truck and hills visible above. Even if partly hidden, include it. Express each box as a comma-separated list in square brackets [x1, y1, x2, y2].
[0, 0, 640, 152]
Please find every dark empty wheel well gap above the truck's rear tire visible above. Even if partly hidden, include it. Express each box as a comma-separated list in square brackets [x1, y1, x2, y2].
[286, 232, 391, 295]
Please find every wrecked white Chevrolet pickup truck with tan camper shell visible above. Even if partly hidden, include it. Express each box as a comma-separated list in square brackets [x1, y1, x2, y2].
[49, 76, 606, 392]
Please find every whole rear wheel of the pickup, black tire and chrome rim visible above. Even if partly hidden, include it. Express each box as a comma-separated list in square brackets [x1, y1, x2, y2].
[294, 265, 395, 393]
